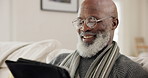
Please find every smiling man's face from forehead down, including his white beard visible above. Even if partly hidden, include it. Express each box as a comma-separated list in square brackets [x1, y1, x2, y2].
[77, 1, 112, 57]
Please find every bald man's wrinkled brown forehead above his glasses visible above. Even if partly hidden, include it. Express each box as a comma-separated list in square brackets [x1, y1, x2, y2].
[78, 0, 109, 17]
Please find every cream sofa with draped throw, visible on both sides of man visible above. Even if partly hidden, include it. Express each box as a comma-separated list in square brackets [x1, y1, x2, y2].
[0, 39, 148, 78]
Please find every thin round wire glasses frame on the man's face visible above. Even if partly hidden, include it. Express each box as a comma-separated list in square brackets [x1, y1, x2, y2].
[72, 16, 112, 29]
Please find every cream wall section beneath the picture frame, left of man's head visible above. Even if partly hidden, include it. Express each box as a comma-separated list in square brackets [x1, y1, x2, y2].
[12, 0, 82, 49]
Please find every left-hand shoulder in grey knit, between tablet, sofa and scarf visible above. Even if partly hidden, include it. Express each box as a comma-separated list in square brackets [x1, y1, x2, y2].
[50, 53, 70, 65]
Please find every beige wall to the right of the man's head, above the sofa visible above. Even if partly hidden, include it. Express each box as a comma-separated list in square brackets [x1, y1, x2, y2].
[119, 0, 148, 56]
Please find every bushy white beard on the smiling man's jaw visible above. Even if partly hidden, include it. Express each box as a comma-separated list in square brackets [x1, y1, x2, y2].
[77, 31, 110, 57]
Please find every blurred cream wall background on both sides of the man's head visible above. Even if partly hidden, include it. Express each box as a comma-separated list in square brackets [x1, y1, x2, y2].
[0, 0, 148, 56]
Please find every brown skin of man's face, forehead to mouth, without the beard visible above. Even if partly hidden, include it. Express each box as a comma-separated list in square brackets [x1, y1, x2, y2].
[78, 3, 111, 45]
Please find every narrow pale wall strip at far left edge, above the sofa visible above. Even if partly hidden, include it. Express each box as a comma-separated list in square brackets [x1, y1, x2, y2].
[0, 0, 11, 41]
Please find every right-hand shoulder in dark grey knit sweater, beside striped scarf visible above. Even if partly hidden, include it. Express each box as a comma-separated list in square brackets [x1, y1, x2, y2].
[111, 55, 148, 78]
